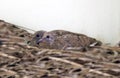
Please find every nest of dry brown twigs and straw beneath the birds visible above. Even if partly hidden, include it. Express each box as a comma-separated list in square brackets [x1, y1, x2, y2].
[0, 20, 120, 78]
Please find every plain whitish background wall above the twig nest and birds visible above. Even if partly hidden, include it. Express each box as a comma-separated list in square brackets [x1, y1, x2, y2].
[0, 0, 120, 44]
